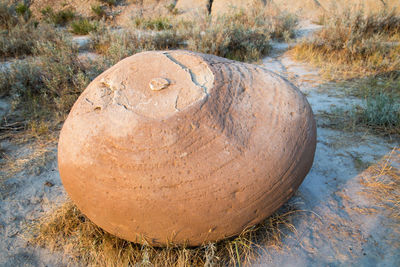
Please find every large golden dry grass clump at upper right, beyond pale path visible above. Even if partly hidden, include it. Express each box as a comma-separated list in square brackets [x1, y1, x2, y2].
[293, 11, 400, 79]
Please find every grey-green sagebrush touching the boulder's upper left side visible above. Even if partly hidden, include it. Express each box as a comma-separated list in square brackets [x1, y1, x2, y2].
[0, 29, 103, 124]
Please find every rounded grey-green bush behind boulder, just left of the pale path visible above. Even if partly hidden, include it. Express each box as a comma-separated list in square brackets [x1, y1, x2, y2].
[187, 9, 297, 61]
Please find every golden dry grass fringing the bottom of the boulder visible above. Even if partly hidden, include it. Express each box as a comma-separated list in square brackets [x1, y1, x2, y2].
[29, 201, 301, 266]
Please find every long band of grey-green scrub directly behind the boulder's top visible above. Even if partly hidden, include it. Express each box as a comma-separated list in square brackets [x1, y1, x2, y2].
[92, 7, 297, 62]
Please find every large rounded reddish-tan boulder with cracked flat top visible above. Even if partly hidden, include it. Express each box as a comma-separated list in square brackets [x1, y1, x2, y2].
[58, 51, 316, 246]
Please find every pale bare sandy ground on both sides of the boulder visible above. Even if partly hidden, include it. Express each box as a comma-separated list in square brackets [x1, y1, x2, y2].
[0, 23, 400, 266]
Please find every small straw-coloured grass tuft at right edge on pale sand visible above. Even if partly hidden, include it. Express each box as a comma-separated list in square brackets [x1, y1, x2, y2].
[361, 148, 400, 223]
